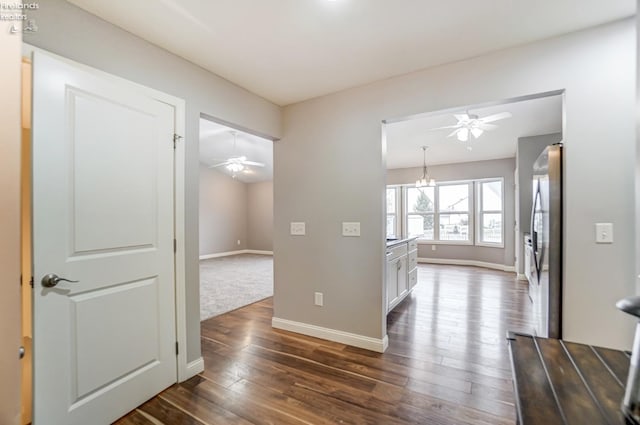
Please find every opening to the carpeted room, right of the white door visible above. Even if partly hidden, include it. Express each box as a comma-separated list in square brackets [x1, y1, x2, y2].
[199, 115, 273, 320]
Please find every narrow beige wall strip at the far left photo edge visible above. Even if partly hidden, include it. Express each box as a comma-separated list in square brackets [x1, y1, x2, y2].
[0, 22, 22, 425]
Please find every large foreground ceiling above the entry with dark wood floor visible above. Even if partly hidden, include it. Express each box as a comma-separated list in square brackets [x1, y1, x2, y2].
[69, 0, 635, 105]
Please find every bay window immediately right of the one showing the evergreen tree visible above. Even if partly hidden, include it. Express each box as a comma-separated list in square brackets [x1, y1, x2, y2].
[438, 183, 471, 242]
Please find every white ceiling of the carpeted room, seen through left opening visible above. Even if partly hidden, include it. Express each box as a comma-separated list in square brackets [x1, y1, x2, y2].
[200, 118, 273, 183]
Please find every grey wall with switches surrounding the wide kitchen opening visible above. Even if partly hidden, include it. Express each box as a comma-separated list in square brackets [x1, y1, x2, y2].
[274, 19, 636, 348]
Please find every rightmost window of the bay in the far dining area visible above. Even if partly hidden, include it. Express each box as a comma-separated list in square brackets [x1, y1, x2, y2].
[477, 180, 504, 246]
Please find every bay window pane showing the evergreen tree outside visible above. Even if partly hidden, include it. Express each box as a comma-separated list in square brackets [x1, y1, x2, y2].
[406, 187, 435, 240]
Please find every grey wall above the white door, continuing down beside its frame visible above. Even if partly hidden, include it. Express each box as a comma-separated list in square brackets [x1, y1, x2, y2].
[24, 0, 281, 362]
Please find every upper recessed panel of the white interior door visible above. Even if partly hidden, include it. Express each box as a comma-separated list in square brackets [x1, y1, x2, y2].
[68, 89, 158, 253]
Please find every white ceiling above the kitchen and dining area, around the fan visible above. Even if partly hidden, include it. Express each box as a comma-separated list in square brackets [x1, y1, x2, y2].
[386, 95, 562, 169]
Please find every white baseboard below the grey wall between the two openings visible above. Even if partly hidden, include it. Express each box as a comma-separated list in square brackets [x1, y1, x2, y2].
[271, 317, 389, 353]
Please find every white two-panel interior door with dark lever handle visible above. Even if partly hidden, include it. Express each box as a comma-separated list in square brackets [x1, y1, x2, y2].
[33, 53, 176, 425]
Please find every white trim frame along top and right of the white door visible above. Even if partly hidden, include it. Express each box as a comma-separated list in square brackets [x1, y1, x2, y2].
[22, 43, 191, 382]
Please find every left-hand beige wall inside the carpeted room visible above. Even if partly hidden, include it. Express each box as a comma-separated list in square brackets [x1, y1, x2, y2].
[199, 164, 248, 256]
